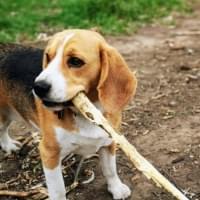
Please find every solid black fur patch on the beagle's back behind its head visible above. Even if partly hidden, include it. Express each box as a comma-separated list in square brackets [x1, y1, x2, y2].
[0, 44, 43, 91]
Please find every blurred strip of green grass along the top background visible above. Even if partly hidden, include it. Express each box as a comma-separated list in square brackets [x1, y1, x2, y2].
[0, 0, 189, 42]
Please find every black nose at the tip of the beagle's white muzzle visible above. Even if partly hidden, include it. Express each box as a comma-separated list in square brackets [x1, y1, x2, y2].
[33, 81, 51, 98]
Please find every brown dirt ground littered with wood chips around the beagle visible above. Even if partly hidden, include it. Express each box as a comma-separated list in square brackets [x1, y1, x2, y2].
[0, 5, 200, 200]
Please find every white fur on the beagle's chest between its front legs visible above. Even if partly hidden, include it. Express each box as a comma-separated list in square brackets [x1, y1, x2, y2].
[55, 115, 112, 158]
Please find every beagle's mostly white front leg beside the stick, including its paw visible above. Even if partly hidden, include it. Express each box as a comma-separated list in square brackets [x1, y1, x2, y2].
[99, 143, 131, 199]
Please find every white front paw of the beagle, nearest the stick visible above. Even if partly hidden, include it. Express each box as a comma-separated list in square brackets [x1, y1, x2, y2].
[108, 181, 131, 199]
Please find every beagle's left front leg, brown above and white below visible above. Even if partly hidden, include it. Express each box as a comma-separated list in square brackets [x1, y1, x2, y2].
[40, 141, 66, 200]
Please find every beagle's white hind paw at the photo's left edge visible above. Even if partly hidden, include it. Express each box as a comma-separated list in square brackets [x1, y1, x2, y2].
[0, 135, 21, 154]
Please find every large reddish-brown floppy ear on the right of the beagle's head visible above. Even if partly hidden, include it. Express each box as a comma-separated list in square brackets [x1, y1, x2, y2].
[97, 44, 137, 113]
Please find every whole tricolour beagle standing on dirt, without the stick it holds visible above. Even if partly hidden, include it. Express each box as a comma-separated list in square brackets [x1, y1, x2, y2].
[0, 29, 137, 200]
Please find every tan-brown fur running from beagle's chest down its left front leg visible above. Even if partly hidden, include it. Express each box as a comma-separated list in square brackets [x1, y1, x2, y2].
[36, 100, 77, 169]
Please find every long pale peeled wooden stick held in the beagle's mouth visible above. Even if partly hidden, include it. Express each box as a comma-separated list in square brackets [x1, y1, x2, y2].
[72, 92, 189, 200]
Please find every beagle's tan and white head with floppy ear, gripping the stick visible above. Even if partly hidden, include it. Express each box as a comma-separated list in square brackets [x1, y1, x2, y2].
[34, 30, 136, 112]
